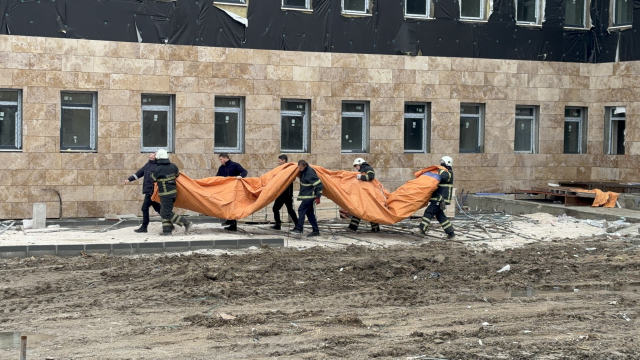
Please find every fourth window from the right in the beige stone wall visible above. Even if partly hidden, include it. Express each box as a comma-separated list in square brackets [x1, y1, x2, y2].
[460, 104, 484, 153]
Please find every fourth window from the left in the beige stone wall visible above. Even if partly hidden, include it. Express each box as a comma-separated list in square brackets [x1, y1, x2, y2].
[214, 96, 244, 153]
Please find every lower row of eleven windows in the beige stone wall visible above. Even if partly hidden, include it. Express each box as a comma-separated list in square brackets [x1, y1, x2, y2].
[0, 90, 626, 154]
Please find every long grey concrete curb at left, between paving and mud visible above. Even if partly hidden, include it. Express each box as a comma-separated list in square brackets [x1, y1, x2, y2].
[0, 239, 284, 259]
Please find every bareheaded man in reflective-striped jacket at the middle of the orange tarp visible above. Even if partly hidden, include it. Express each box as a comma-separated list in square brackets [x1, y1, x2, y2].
[291, 160, 323, 237]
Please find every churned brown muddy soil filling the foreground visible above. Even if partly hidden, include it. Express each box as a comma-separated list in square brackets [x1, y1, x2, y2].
[0, 237, 640, 360]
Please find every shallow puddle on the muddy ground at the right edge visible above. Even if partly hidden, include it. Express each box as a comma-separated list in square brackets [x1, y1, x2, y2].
[480, 284, 640, 299]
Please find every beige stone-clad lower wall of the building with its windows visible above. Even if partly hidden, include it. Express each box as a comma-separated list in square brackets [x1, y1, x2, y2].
[0, 35, 640, 219]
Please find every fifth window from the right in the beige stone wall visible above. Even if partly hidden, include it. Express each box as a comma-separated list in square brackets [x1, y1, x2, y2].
[404, 103, 431, 153]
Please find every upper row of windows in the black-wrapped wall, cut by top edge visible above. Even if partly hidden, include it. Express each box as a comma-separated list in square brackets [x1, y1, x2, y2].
[214, 0, 633, 28]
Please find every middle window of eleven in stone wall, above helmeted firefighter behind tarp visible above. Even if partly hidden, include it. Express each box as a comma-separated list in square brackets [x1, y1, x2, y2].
[342, 101, 369, 153]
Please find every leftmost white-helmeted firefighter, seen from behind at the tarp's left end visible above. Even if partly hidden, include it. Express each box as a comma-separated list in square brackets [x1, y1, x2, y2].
[151, 150, 191, 235]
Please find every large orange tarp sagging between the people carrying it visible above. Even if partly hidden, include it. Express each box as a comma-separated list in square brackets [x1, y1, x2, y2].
[153, 163, 438, 224]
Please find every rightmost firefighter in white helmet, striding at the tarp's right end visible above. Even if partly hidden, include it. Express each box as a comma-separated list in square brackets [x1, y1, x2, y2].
[418, 156, 455, 240]
